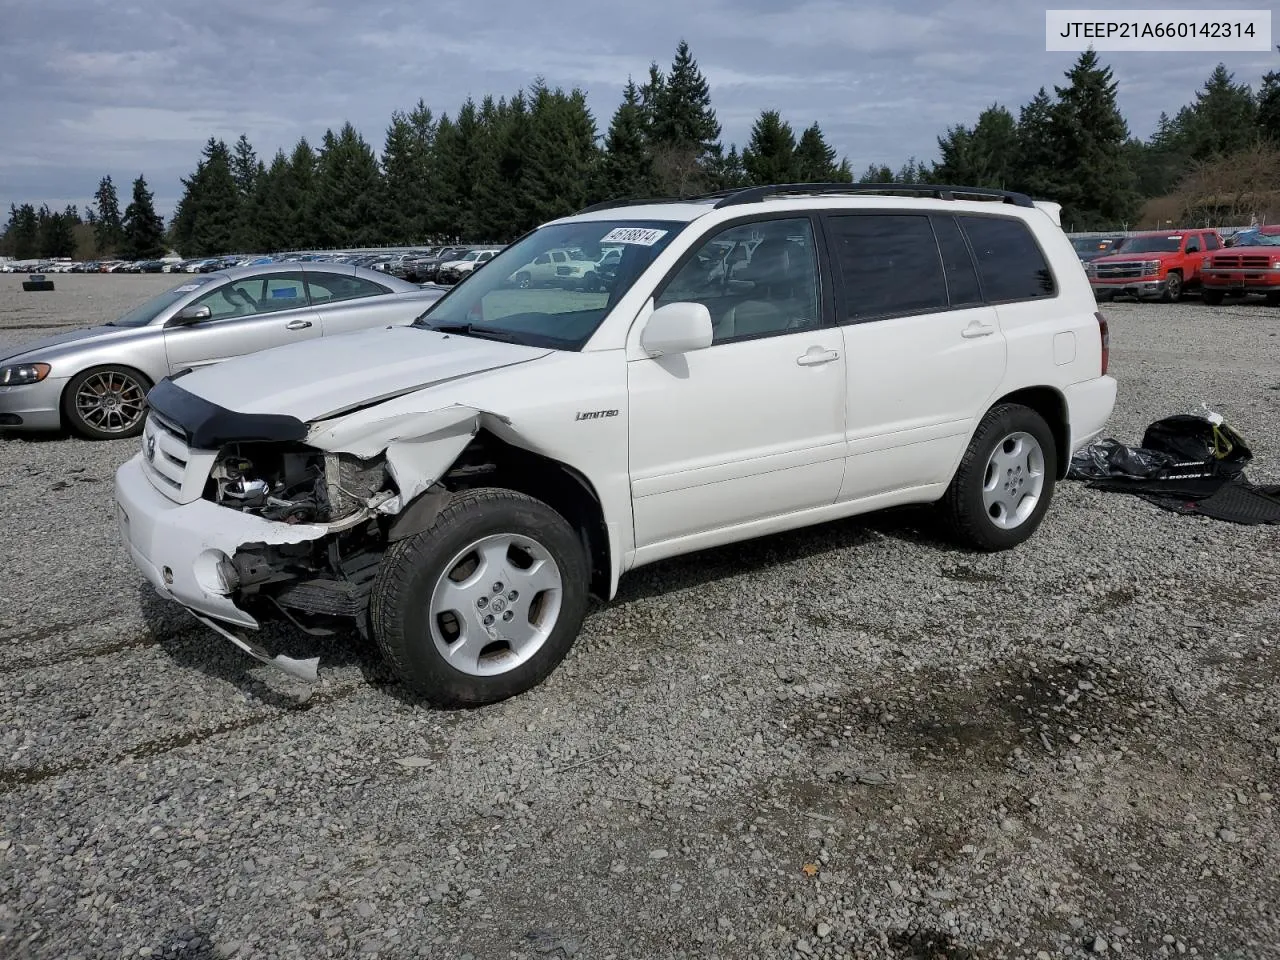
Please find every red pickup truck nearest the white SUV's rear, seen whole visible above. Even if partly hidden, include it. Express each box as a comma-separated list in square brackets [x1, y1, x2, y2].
[1084, 230, 1222, 302]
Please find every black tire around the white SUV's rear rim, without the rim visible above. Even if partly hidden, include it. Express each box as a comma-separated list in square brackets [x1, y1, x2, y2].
[938, 403, 1057, 552]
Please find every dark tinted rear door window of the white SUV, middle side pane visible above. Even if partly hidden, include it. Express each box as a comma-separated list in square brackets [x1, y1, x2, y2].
[828, 214, 947, 323]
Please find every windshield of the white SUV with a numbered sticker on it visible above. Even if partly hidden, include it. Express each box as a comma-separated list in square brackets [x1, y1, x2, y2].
[413, 220, 685, 349]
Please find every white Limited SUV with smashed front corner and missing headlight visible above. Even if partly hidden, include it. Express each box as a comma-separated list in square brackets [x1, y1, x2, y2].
[115, 184, 1116, 705]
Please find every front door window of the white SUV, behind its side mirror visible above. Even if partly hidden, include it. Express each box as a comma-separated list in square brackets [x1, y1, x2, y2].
[654, 218, 820, 343]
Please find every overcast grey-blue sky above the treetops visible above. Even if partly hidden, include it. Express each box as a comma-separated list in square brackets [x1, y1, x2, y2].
[0, 0, 1280, 215]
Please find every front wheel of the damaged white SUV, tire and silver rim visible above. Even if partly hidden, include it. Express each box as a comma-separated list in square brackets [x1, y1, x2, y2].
[371, 488, 590, 707]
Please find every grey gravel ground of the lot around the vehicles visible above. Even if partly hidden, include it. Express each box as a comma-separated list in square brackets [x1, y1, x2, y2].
[0, 275, 1280, 960]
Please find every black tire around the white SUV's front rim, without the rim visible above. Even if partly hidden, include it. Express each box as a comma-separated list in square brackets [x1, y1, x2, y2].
[370, 488, 590, 708]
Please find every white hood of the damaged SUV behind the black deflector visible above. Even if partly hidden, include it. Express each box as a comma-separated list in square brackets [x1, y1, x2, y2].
[166, 326, 552, 422]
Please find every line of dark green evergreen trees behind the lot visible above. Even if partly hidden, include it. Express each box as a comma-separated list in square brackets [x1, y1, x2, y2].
[0, 41, 1280, 259]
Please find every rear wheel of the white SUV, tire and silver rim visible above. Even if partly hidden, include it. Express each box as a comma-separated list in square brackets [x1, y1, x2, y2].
[940, 403, 1057, 550]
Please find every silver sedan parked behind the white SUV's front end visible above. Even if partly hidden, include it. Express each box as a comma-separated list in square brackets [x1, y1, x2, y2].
[0, 262, 447, 440]
